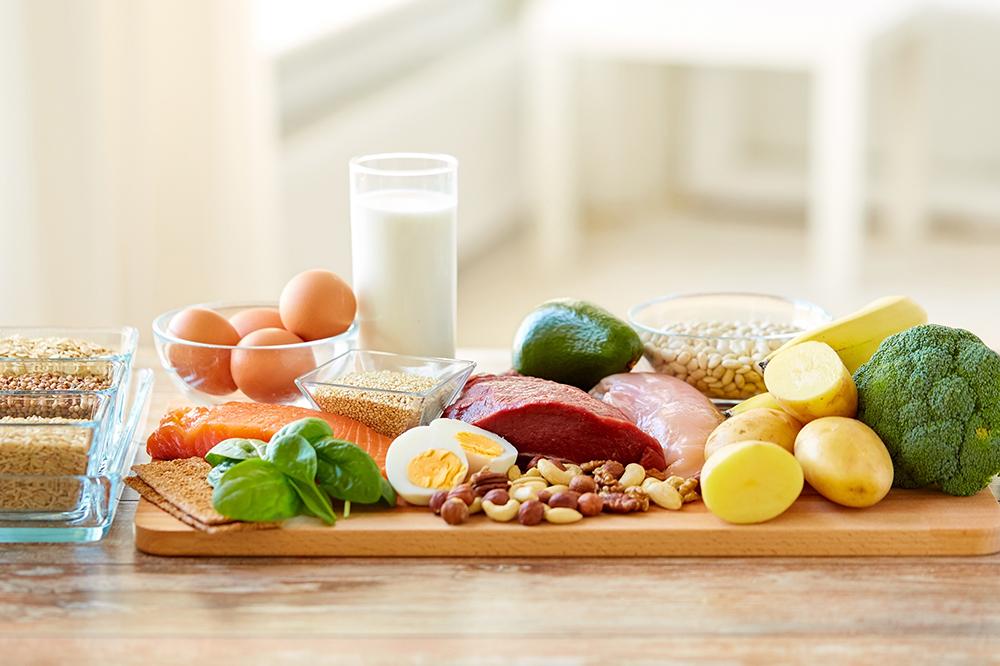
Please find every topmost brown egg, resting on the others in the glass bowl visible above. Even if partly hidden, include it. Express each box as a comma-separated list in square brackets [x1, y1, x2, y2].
[278, 268, 357, 340]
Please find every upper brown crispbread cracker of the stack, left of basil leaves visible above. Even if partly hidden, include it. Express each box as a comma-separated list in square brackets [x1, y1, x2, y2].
[132, 458, 233, 525]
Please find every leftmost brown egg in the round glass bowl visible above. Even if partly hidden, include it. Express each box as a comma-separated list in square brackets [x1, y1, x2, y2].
[167, 308, 240, 395]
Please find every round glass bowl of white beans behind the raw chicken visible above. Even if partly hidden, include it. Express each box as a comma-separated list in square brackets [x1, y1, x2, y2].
[628, 293, 831, 406]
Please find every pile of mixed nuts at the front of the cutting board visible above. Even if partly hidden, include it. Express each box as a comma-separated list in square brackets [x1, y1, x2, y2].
[430, 458, 699, 525]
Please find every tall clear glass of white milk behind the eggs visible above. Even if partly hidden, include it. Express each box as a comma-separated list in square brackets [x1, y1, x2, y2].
[351, 153, 458, 358]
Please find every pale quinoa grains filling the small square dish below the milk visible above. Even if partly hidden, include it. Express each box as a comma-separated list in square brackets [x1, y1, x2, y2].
[313, 370, 437, 437]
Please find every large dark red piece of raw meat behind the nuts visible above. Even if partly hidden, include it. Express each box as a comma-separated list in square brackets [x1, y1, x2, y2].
[444, 375, 666, 469]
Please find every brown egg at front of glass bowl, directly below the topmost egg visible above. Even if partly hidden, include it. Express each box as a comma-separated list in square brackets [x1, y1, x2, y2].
[230, 328, 316, 402]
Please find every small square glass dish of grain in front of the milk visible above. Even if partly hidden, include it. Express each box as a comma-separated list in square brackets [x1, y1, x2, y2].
[295, 350, 476, 437]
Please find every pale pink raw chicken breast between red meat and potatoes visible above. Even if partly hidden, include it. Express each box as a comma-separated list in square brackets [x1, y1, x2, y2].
[590, 372, 725, 478]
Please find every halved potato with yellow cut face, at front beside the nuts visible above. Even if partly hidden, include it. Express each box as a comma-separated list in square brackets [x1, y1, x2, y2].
[701, 440, 802, 524]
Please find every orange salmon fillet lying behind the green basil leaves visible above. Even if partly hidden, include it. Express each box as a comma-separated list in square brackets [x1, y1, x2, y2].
[146, 402, 392, 471]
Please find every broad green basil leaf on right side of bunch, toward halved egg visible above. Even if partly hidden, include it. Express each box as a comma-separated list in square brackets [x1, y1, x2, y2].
[313, 438, 383, 504]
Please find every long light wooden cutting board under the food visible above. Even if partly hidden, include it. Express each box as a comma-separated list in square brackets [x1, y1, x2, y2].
[135, 490, 1000, 557]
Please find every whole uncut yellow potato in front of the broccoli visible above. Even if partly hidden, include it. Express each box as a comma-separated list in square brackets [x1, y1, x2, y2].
[795, 416, 892, 507]
